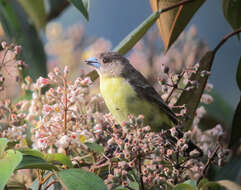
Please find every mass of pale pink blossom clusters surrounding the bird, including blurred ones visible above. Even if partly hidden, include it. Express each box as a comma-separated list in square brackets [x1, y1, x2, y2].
[0, 24, 232, 189]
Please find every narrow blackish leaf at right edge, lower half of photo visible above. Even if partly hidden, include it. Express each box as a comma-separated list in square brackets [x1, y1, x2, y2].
[229, 97, 241, 147]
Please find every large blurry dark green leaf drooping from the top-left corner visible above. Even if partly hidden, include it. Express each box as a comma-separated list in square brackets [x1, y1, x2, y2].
[0, 0, 46, 79]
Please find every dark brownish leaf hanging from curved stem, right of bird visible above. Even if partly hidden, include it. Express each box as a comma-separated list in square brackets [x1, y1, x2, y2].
[176, 51, 215, 129]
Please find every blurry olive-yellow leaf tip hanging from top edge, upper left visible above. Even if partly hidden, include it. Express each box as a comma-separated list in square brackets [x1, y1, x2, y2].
[18, 0, 46, 31]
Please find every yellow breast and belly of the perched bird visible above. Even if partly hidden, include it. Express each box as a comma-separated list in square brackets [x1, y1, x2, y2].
[100, 77, 172, 131]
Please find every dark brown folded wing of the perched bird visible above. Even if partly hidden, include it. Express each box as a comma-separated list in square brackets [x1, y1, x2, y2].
[122, 65, 178, 124]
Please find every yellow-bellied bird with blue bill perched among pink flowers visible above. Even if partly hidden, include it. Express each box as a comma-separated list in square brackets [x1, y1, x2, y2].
[85, 52, 200, 154]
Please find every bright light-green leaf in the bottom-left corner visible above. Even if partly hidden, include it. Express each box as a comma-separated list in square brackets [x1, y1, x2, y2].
[0, 149, 22, 190]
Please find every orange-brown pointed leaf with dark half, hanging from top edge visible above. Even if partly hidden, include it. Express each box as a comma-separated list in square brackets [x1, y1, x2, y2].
[150, 0, 205, 51]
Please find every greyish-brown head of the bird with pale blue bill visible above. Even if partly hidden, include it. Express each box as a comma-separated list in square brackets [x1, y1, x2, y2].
[85, 52, 129, 77]
